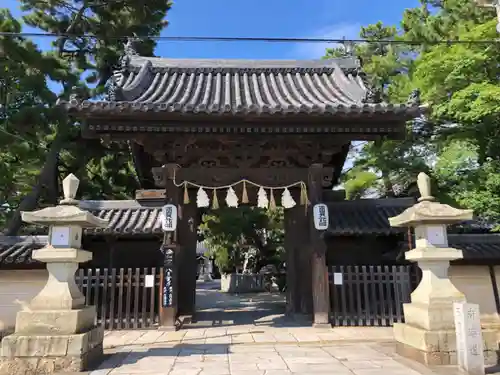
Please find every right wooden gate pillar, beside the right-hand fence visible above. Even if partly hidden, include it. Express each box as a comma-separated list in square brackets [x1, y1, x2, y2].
[307, 164, 331, 327]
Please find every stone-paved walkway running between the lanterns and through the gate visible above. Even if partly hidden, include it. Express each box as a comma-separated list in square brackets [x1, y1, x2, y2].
[85, 283, 458, 375]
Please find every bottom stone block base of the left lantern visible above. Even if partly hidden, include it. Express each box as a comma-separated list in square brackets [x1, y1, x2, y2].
[0, 327, 104, 375]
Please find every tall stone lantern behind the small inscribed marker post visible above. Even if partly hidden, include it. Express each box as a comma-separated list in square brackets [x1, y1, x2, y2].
[389, 173, 498, 365]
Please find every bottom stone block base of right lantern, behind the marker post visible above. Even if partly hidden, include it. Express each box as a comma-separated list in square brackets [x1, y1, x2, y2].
[394, 323, 498, 366]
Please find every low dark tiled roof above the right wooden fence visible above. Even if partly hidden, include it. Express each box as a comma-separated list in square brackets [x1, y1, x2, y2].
[327, 198, 415, 236]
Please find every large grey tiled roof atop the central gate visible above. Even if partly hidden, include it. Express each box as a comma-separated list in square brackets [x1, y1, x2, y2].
[59, 56, 421, 117]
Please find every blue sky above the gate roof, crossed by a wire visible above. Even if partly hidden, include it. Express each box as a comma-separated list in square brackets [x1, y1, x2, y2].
[7, 0, 418, 59]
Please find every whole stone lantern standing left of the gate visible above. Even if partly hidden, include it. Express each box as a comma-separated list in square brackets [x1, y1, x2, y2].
[0, 174, 107, 375]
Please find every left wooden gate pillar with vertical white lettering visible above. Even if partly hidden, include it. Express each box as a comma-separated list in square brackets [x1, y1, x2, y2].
[160, 164, 180, 330]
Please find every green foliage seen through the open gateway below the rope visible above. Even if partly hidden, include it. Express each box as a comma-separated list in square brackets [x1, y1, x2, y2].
[200, 206, 284, 272]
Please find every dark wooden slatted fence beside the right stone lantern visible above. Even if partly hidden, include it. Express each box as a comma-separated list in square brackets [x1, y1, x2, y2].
[329, 266, 420, 326]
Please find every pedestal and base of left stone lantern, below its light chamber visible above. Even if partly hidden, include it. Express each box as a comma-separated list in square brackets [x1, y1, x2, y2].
[0, 247, 104, 374]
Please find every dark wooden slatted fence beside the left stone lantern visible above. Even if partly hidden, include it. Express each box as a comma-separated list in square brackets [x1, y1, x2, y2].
[76, 268, 161, 330]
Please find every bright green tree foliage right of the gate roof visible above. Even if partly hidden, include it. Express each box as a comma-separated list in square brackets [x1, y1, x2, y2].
[327, 0, 500, 229]
